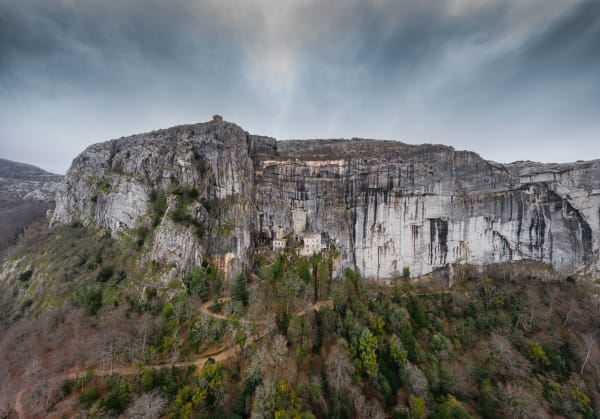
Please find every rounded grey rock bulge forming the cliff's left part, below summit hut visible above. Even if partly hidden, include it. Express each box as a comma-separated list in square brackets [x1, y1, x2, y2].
[52, 121, 268, 276]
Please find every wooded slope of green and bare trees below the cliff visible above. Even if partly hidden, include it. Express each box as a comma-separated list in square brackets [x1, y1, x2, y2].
[0, 224, 600, 418]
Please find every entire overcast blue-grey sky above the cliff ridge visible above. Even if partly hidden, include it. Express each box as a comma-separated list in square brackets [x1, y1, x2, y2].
[0, 0, 600, 173]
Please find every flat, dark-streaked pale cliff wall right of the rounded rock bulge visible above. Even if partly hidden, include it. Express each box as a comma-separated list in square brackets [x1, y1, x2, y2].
[257, 140, 600, 280]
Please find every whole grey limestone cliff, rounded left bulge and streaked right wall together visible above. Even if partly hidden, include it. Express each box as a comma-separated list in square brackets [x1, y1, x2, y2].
[53, 121, 600, 280]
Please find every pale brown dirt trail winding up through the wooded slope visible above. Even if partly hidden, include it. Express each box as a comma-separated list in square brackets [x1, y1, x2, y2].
[15, 297, 333, 419]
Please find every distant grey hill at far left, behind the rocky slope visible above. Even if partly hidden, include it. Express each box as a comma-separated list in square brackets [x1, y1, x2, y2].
[0, 158, 63, 254]
